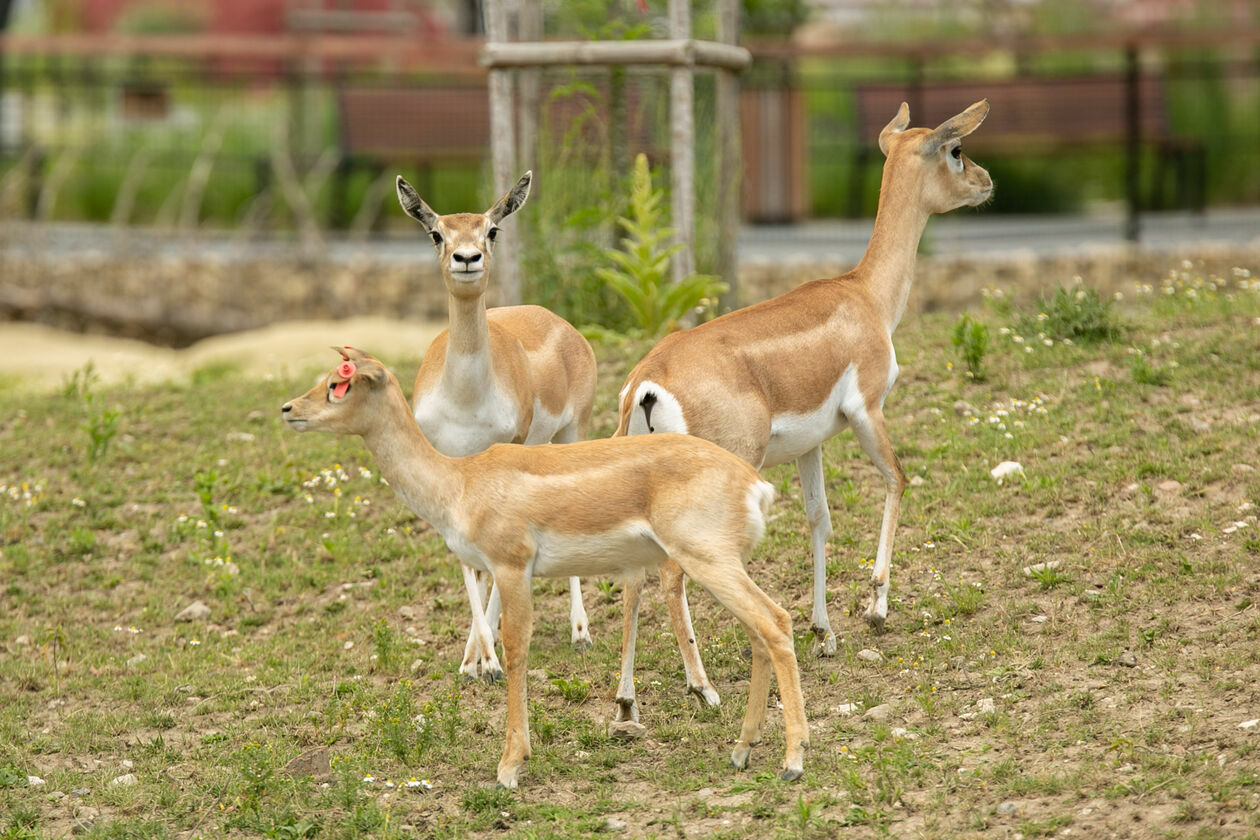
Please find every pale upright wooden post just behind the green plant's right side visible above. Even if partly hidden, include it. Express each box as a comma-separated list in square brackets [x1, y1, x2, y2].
[669, 0, 696, 283]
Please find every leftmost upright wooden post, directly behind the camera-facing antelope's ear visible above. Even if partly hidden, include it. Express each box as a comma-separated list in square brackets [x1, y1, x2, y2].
[485, 0, 520, 306]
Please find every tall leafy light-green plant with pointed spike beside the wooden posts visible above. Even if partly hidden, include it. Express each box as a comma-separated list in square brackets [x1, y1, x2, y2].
[596, 154, 727, 335]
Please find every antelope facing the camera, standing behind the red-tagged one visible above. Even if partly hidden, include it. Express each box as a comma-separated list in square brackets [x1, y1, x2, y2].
[397, 173, 595, 679]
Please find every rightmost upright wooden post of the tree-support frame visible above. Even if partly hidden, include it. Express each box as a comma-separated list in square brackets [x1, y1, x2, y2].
[714, 0, 743, 311]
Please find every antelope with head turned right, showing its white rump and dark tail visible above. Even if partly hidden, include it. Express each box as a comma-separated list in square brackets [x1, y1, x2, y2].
[616, 99, 993, 704]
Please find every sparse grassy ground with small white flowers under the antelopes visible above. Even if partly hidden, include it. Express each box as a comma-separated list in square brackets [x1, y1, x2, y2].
[0, 268, 1260, 840]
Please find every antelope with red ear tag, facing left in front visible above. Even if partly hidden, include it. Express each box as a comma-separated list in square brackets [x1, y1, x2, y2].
[281, 348, 809, 788]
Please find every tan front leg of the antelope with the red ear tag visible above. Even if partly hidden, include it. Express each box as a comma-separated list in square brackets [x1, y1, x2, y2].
[495, 569, 534, 790]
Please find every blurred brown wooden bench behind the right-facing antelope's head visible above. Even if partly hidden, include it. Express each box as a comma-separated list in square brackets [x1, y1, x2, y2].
[849, 76, 1205, 215]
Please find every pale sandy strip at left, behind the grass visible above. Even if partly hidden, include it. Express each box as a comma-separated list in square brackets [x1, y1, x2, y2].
[0, 317, 446, 390]
